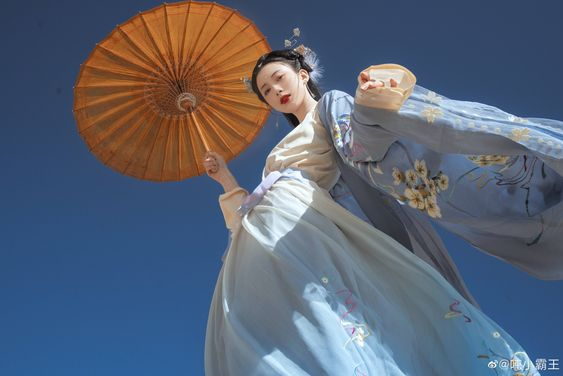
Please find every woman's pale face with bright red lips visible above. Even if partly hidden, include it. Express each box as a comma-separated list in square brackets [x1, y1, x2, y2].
[256, 61, 311, 114]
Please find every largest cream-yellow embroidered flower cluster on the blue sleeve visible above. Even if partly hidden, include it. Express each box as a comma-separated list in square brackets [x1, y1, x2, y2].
[392, 159, 449, 218]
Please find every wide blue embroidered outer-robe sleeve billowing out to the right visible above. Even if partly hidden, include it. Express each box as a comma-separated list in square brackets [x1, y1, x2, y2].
[319, 85, 563, 279]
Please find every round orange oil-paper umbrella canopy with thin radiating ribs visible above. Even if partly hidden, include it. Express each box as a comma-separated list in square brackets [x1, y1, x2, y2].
[74, 1, 270, 181]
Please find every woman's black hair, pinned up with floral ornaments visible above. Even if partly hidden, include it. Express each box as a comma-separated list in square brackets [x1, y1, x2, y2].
[252, 49, 321, 128]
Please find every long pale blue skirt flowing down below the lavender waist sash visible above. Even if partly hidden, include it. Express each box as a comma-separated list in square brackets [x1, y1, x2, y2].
[205, 167, 539, 376]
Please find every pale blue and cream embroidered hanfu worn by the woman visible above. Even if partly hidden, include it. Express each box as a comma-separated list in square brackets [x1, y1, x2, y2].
[205, 64, 562, 376]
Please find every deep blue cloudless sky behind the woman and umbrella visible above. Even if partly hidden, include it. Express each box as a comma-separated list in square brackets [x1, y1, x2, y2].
[0, 0, 563, 376]
